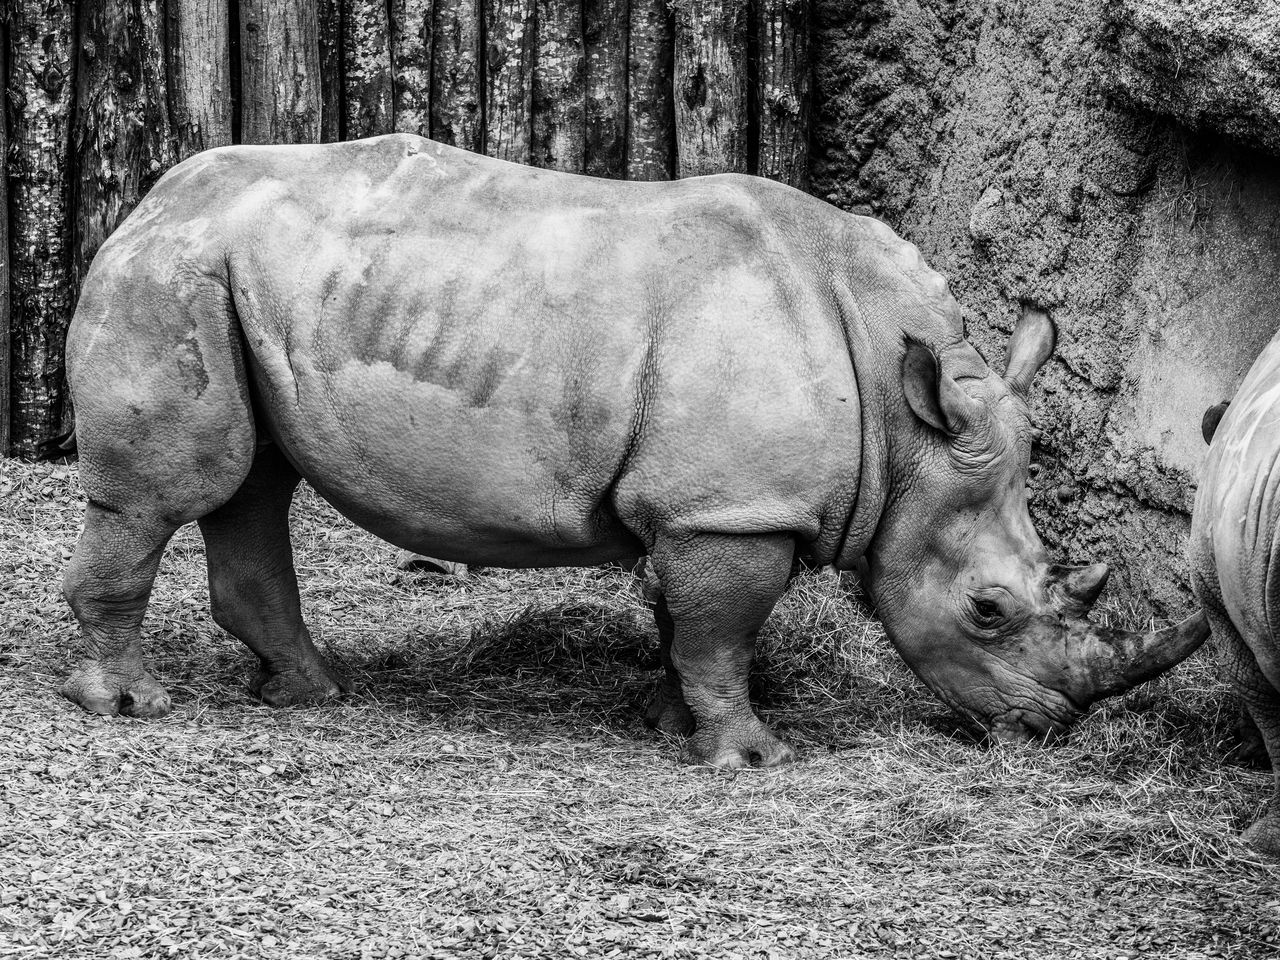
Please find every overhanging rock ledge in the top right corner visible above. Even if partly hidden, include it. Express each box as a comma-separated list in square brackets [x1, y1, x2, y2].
[1103, 0, 1280, 154]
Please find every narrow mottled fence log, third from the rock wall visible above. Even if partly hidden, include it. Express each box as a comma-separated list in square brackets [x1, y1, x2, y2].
[626, 0, 676, 180]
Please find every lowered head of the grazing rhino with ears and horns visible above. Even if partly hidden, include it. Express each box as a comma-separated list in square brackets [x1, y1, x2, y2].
[868, 311, 1208, 740]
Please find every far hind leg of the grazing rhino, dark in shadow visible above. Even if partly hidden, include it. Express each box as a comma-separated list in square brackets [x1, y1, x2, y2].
[200, 444, 352, 707]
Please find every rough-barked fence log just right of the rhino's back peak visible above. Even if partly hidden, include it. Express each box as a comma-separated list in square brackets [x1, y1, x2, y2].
[430, 0, 484, 152]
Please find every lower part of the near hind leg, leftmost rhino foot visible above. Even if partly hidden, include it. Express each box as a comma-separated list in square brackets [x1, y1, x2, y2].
[61, 500, 177, 717]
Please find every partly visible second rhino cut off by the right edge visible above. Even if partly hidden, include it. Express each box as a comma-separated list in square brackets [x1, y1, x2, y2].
[1190, 334, 1280, 856]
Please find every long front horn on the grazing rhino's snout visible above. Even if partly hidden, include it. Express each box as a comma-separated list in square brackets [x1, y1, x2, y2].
[1076, 613, 1208, 700]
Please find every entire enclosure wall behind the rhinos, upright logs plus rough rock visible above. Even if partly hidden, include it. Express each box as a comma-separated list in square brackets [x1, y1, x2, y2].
[0, 0, 1280, 612]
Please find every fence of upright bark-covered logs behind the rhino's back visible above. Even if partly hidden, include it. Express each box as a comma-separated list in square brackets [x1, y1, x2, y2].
[0, 0, 812, 457]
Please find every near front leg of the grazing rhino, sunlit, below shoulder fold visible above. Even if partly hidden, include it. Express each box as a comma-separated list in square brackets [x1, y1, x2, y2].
[653, 534, 795, 768]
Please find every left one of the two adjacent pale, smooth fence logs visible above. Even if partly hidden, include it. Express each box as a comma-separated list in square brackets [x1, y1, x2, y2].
[165, 0, 232, 160]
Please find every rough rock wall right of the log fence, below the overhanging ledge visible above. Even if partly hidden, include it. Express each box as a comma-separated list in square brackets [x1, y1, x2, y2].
[813, 0, 1280, 614]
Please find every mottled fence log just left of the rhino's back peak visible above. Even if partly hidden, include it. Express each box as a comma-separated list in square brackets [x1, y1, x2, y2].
[342, 0, 394, 140]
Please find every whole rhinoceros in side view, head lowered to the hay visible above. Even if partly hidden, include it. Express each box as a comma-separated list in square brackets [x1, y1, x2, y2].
[55, 136, 1206, 767]
